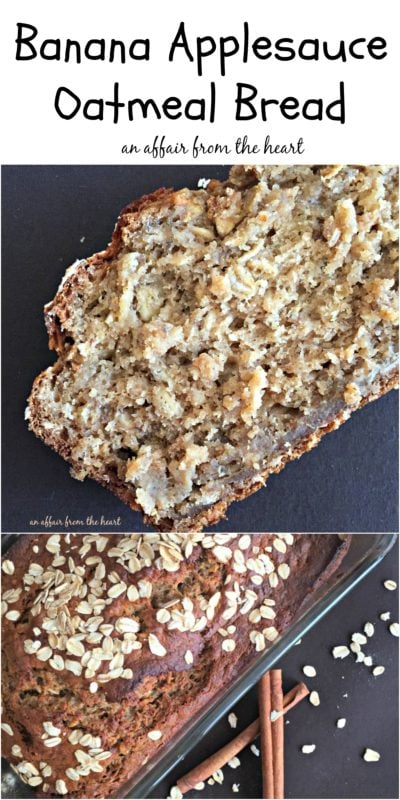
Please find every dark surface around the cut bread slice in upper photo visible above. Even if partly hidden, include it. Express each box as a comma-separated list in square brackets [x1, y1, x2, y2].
[2, 166, 398, 532]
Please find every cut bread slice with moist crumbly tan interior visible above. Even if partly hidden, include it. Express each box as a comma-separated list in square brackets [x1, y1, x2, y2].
[27, 166, 398, 531]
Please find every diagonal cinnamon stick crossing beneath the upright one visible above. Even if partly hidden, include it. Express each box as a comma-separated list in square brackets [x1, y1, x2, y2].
[177, 683, 310, 794]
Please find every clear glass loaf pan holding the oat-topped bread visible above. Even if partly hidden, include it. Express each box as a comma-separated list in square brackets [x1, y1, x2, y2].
[2, 533, 397, 799]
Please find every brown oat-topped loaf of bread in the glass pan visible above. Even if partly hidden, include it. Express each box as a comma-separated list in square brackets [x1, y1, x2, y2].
[2, 533, 350, 798]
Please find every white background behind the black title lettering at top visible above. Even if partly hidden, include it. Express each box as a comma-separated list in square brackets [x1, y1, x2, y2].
[1, 0, 400, 164]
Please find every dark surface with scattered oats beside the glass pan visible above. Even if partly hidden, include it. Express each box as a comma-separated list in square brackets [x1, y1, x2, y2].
[152, 546, 399, 800]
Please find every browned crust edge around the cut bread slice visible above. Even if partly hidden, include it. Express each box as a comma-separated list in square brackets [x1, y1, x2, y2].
[28, 168, 398, 531]
